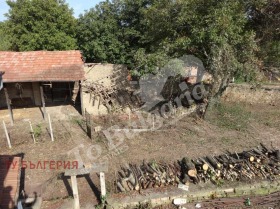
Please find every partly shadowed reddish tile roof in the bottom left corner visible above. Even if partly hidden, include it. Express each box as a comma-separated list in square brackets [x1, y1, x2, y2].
[0, 156, 21, 209]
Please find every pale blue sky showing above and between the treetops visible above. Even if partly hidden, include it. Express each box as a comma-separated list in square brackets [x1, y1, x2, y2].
[0, 0, 102, 21]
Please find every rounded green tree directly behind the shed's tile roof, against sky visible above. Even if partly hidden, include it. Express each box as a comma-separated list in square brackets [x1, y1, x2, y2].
[7, 0, 76, 51]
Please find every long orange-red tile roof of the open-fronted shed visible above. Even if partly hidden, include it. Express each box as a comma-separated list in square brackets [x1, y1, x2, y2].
[0, 50, 84, 83]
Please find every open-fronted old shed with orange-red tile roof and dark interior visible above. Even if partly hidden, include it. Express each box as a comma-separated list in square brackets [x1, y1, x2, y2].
[0, 50, 84, 112]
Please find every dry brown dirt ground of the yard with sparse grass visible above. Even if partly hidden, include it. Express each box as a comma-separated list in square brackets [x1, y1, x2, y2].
[0, 97, 280, 209]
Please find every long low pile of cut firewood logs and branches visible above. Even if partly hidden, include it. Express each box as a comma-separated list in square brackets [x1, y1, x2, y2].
[116, 144, 280, 192]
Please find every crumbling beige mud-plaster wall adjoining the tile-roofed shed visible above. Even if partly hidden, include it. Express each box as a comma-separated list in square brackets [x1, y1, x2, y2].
[82, 63, 129, 115]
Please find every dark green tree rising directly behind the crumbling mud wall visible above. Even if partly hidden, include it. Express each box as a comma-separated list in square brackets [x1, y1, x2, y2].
[77, 0, 150, 64]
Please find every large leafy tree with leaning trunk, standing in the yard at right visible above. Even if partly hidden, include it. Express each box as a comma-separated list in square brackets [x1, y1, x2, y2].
[135, 0, 257, 92]
